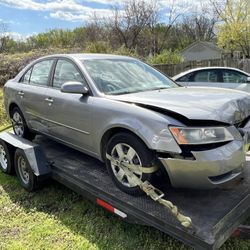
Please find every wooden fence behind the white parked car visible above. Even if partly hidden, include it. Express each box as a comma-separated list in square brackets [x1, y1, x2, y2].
[154, 58, 250, 76]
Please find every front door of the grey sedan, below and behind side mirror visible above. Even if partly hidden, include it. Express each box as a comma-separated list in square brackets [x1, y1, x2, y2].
[43, 59, 93, 152]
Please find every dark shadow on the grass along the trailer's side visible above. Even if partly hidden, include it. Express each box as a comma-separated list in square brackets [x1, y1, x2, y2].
[0, 174, 188, 250]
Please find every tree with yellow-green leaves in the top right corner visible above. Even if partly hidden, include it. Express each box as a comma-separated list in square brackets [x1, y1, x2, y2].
[212, 0, 250, 58]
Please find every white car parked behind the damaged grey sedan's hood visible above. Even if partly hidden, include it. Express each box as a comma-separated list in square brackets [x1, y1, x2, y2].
[172, 67, 250, 92]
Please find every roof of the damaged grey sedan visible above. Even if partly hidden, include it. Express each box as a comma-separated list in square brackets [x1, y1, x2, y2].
[39, 53, 134, 60]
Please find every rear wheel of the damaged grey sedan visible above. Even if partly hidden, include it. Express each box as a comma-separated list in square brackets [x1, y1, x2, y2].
[10, 107, 35, 140]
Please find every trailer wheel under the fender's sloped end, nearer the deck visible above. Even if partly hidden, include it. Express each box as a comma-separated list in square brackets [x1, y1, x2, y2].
[14, 149, 39, 192]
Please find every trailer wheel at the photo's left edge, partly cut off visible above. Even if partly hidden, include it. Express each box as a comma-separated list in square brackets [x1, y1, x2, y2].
[0, 140, 15, 174]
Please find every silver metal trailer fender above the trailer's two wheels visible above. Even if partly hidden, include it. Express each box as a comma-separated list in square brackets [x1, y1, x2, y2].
[0, 132, 51, 176]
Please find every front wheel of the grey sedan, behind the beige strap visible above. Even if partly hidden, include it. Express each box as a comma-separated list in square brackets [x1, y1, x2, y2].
[106, 133, 155, 196]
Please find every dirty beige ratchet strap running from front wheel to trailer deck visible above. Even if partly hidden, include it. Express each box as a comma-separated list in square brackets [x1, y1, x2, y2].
[106, 154, 192, 227]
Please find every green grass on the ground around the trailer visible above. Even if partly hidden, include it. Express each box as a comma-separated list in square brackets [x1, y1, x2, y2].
[0, 89, 250, 250]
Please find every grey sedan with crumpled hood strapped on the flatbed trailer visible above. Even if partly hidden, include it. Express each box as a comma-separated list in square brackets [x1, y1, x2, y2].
[0, 54, 250, 194]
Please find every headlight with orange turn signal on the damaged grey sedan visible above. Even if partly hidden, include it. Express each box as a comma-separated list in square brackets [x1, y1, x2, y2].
[169, 126, 234, 144]
